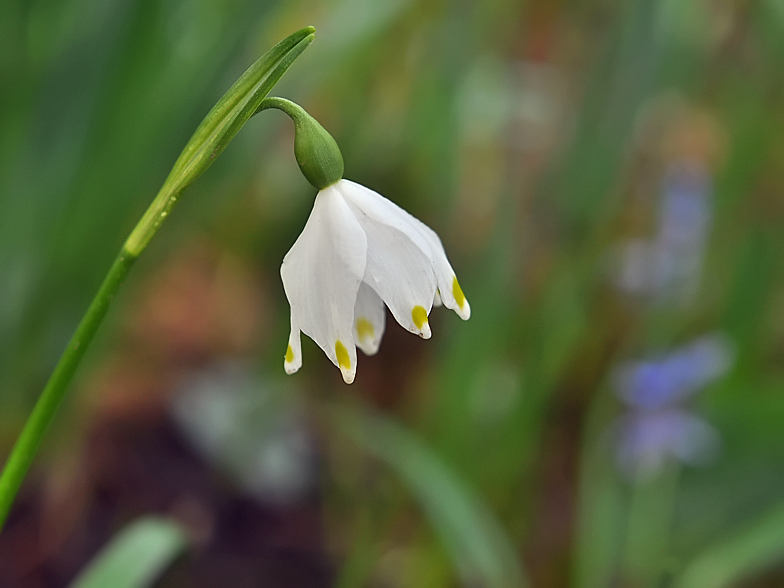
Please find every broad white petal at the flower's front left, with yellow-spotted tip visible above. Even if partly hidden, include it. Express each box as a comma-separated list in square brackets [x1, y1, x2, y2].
[280, 186, 367, 384]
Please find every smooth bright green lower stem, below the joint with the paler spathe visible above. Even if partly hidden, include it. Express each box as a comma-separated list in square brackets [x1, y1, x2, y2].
[0, 248, 136, 531]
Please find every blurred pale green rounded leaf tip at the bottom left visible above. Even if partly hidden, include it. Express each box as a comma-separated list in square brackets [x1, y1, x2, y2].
[70, 517, 188, 588]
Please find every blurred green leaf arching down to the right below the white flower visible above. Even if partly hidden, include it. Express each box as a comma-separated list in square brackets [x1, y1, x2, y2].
[331, 407, 527, 588]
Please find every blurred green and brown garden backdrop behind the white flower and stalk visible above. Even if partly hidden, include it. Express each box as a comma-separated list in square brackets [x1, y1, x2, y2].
[0, 0, 784, 588]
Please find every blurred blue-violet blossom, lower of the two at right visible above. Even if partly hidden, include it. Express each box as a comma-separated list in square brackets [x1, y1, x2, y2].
[615, 335, 734, 479]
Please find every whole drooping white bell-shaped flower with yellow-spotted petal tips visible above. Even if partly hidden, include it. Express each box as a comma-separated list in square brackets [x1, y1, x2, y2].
[280, 180, 471, 384]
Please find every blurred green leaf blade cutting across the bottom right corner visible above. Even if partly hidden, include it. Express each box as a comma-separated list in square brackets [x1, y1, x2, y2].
[674, 503, 784, 588]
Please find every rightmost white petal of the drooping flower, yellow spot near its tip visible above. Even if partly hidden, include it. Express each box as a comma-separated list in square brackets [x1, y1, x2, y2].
[337, 180, 471, 320]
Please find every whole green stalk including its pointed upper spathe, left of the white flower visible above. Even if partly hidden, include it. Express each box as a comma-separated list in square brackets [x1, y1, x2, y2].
[0, 27, 315, 531]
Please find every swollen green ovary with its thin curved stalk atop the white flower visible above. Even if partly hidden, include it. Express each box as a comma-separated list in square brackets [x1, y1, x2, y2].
[257, 97, 343, 190]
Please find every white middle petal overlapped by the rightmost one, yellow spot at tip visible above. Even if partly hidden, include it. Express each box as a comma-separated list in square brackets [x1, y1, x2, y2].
[335, 180, 436, 339]
